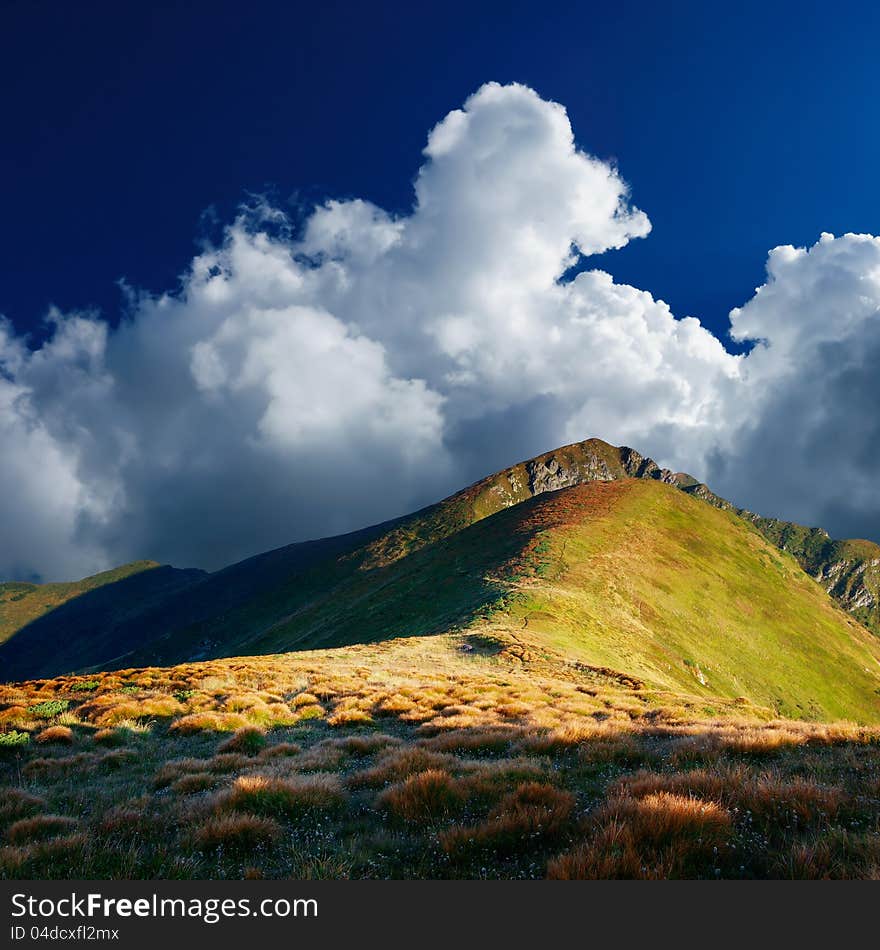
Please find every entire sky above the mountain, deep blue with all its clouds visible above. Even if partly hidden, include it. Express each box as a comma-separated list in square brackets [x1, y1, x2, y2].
[0, 0, 880, 580]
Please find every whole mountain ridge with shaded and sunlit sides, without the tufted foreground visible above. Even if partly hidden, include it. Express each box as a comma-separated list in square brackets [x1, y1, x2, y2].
[0, 439, 880, 722]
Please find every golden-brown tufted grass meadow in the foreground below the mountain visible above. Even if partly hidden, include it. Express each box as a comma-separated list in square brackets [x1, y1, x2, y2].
[0, 629, 880, 879]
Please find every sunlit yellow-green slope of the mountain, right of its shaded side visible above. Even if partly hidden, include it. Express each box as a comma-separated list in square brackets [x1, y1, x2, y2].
[491, 480, 880, 721]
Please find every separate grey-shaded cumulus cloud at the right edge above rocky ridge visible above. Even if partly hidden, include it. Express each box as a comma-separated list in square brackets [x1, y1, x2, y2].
[709, 234, 880, 540]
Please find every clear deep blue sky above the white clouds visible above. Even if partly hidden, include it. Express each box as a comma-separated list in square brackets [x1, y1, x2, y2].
[0, 0, 880, 346]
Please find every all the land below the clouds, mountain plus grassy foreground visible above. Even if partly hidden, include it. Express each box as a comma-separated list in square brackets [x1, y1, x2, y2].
[0, 440, 880, 880]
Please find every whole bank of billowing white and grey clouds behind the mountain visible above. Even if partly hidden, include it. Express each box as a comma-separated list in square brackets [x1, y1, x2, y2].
[0, 84, 880, 578]
